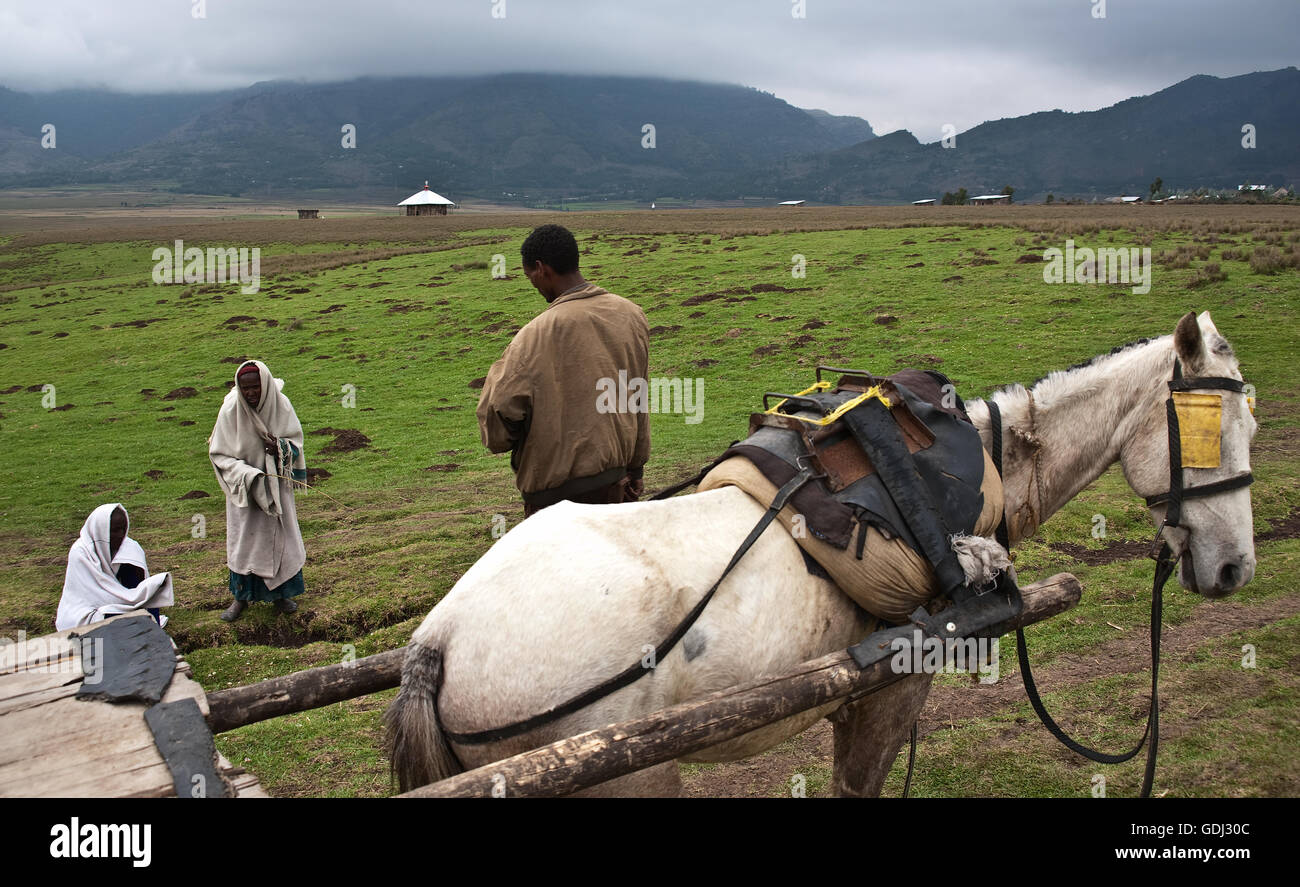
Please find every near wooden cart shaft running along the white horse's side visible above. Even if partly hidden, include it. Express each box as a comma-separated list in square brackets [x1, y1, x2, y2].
[399, 574, 1083, 797]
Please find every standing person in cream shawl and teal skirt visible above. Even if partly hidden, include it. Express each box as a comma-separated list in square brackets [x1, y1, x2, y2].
[208, 360, 307, 622]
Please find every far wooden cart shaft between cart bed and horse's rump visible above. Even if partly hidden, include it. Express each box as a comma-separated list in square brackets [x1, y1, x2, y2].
[208, 648, 406, 734]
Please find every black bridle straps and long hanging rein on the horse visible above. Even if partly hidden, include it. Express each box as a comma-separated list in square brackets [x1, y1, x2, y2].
[988, 356, 1255, 797]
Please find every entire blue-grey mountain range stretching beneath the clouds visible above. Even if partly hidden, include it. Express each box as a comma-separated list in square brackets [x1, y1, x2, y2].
[0, 68, 1300, 203]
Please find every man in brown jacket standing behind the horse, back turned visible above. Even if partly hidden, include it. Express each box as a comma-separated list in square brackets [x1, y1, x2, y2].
[478, 225, 650, 518]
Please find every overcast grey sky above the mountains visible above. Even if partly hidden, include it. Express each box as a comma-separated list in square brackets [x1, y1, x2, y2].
[0, 0, 1300, 142]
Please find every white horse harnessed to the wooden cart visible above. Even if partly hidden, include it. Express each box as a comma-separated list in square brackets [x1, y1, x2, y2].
[387, 312, 1256, 796]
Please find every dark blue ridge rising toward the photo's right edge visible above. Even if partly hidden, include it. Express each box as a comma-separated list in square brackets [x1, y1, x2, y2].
[783, 68, 1300, 203]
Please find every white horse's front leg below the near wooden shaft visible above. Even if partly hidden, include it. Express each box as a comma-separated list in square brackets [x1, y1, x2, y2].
[828, 674, 935, 797]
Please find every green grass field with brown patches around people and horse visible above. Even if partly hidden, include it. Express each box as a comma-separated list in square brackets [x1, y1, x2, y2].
[0, 208, 1300, 796]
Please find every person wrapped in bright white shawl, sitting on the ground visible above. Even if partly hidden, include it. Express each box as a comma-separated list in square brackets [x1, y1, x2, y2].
[55, 502, 176, 631]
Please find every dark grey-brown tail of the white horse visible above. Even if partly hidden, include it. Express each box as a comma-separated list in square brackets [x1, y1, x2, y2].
[384, 641, 463, 792]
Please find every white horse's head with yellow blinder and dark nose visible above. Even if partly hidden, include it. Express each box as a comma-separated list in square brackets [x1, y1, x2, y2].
[1121, 311, 1256, 597]
